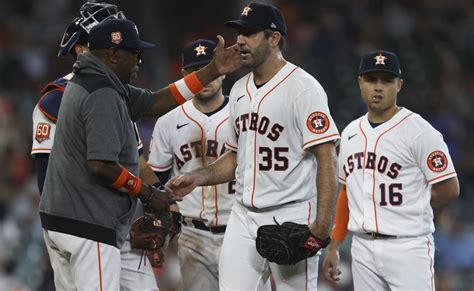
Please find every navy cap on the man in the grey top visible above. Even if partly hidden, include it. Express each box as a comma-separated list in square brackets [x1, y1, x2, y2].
[89, 17, 155, 50]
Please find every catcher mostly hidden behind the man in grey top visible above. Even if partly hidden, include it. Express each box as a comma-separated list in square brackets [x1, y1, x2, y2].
[31, 2, 158, 290]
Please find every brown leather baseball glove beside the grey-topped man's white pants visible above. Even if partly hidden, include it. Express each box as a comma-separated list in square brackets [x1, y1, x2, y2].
[130, 212, 173, 267]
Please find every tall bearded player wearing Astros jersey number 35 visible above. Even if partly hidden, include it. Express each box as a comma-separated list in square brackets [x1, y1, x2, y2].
[165, 3, 339, 290]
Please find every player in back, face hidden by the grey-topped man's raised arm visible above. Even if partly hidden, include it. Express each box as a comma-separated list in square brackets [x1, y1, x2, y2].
[148, 39, 235, 290]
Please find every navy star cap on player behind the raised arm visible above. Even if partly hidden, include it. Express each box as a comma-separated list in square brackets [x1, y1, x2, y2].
[182, 39, 217, 70]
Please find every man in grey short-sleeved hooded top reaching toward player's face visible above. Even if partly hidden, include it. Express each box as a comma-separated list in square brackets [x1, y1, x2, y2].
[35, 7, 239, 290]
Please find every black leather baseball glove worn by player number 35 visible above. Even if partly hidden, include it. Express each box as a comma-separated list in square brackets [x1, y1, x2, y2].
[256, 222, 331, 265]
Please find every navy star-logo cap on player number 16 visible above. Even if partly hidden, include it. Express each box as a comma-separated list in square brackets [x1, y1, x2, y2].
[359, 50, 402, 78]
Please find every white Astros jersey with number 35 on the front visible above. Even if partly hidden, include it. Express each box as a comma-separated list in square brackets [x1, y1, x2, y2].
[226, 63, 339, 208]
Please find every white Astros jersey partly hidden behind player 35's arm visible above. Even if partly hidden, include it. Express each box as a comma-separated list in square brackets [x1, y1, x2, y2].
[148, 101, 235, 227]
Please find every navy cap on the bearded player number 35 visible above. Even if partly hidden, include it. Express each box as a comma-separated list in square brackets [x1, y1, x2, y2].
[225, 3, 286, 35]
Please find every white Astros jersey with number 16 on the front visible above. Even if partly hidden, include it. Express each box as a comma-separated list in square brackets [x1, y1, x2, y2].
[339, 108, 456, 236]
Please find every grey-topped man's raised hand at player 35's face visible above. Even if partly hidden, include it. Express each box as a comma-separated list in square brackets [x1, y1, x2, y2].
[209, 35, 242, 75]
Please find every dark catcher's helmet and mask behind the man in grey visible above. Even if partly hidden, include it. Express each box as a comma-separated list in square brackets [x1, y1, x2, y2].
[58, 2, 125, 57]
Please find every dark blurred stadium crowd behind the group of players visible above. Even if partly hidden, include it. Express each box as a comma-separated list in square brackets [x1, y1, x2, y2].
[0, 0, 474, 290]
